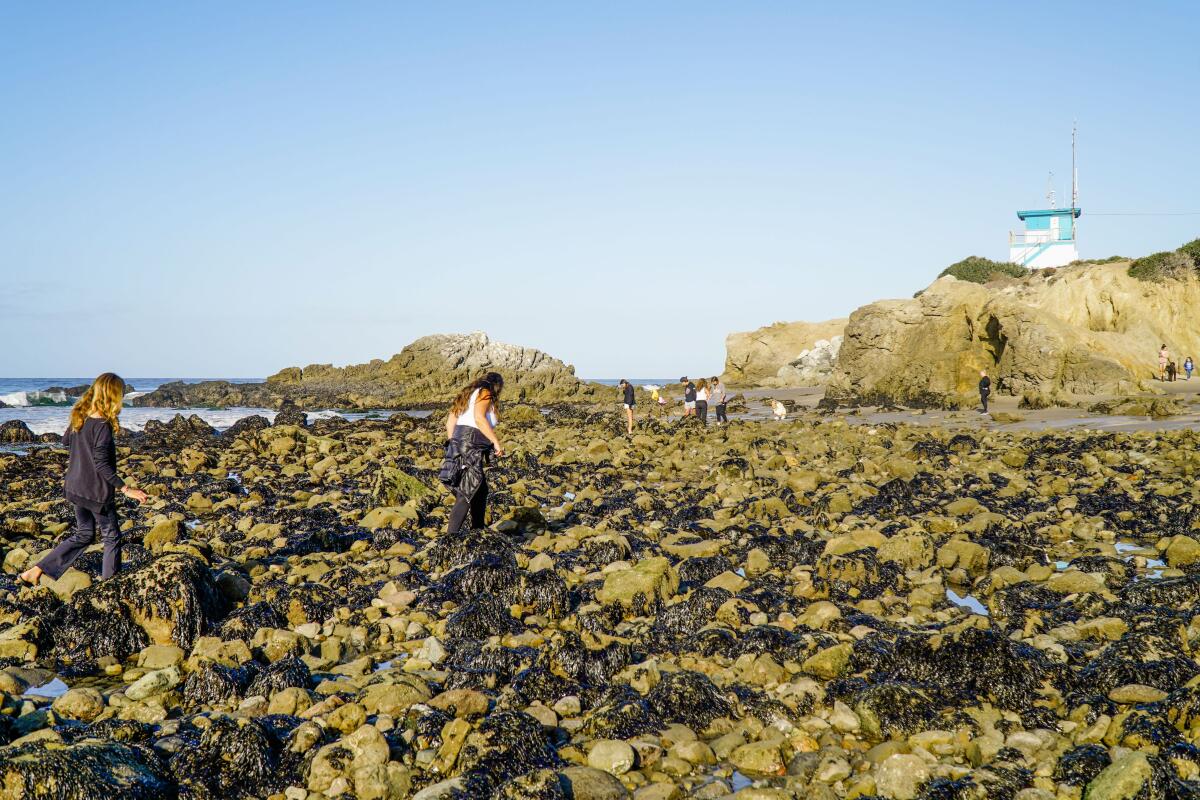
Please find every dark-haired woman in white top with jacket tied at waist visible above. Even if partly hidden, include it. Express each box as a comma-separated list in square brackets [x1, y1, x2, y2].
[440, 372, 504, 534]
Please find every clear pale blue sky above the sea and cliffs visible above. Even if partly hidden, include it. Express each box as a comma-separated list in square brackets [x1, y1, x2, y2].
[0, 0, 1200, 377]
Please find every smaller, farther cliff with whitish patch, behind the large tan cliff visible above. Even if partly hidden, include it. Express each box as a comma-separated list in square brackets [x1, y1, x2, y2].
[725, 319, 846, 386]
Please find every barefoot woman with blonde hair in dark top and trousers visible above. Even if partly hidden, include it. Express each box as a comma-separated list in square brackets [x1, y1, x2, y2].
[20, 372, 148, 587]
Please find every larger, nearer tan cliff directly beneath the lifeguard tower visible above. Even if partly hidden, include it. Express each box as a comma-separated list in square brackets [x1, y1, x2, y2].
[828, 261, 1200, 405]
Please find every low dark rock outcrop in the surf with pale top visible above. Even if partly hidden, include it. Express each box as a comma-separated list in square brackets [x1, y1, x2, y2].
[133, 332, 600, 409]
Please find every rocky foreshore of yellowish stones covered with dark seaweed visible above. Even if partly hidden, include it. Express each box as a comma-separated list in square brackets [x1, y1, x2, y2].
[0, 405, 1200, 800]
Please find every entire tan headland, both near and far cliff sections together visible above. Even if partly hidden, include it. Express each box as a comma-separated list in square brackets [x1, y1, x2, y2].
[727, 246, 1200, 408]
